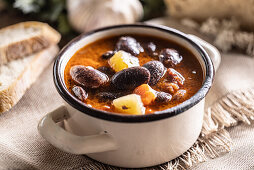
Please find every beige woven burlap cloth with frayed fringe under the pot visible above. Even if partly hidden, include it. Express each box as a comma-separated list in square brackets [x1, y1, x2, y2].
[0, 19, 254, 170]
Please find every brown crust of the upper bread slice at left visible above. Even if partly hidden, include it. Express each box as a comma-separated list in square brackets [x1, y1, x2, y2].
[0, 21, 61, 65]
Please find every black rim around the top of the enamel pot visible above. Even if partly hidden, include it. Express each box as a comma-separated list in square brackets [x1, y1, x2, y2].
[53, 24, 214, 123]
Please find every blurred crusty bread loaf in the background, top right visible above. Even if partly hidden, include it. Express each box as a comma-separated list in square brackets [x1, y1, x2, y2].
[165, 0, 254, 30]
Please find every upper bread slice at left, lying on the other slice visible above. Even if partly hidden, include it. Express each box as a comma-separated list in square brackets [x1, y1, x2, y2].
[0, 21, 61, 65]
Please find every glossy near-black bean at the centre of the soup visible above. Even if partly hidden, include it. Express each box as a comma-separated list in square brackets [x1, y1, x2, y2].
[111, 66, 150, 90]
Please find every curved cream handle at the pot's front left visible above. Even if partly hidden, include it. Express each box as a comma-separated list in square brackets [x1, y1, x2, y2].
[38, 106, 117, 154]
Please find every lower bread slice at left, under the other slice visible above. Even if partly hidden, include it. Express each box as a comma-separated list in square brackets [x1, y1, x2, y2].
[0, 45, 59, 113]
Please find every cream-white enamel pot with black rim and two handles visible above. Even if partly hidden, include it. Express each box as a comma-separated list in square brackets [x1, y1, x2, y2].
[38, 24, 220, 168]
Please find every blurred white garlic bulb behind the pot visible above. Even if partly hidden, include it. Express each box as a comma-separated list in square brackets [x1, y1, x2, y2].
[67, 0, 143, 32]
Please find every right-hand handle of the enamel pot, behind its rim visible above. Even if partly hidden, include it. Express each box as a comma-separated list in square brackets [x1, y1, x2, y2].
[188, 34, 221, 71]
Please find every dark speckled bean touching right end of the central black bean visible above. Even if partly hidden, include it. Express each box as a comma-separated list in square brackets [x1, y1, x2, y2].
[143, 61, 166, 86]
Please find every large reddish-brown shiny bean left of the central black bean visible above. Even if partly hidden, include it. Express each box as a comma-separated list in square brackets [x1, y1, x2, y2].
[70, 65, 109, 88]
